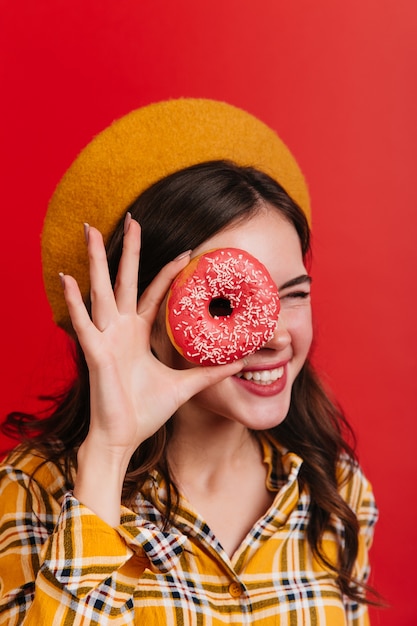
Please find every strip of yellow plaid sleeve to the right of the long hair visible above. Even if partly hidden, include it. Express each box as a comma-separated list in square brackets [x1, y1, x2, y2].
[345, 469, 378, 626]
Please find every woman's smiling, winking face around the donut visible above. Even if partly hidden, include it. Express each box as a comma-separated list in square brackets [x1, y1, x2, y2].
[152, 205, 313, 430]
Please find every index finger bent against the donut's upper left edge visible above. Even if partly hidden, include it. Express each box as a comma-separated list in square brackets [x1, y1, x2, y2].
[137, 250, 191, 325]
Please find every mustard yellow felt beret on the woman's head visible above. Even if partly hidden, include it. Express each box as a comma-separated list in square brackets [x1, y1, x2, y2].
[42, 98, 310, 330]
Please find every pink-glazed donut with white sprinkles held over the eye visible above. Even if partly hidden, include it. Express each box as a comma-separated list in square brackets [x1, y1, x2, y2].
[166, 248, 280, 365]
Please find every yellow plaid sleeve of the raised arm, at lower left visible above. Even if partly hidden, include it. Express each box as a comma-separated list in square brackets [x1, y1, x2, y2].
[0, 460, 185, 626]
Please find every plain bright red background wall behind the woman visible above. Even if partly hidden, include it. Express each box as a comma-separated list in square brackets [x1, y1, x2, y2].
[0, 0, 417, 626]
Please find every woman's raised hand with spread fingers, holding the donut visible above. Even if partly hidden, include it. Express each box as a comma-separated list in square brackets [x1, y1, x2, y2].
[62, 214, 242, 488]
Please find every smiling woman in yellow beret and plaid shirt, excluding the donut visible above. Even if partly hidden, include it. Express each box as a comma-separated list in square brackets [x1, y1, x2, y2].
[0, 100, 376, 626]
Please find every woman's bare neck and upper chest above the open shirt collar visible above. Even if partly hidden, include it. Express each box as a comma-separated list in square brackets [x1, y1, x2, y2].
[168, 413, 274, 556]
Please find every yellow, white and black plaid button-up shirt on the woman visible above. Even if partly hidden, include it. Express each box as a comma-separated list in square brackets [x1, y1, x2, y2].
[0, 440, 377, 626]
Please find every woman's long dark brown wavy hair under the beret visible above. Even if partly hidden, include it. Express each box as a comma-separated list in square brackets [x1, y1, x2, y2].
[2, 161, 374, 602]
